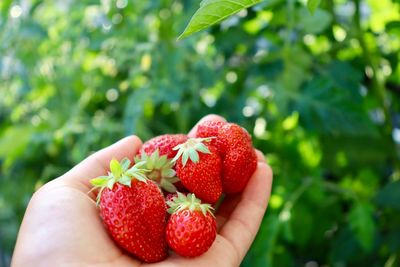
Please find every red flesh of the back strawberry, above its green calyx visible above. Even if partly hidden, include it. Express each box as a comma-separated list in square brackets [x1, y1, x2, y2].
[138, 134, 188, 159]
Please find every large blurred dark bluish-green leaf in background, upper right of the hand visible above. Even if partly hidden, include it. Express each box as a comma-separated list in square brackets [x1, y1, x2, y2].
[293, 77, 377, 136]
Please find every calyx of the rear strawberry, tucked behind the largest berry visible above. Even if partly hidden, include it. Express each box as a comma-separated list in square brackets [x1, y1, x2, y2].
[135, 149, 179, 193]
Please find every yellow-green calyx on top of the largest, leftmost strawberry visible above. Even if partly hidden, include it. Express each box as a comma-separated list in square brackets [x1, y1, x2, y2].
[90, 158, 148, 204]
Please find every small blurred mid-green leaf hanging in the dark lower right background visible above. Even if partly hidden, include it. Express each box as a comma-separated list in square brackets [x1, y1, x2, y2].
[348, 202, 375, 251]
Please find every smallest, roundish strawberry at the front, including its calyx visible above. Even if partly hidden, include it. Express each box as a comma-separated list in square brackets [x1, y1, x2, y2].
[166, 193, 217, 257]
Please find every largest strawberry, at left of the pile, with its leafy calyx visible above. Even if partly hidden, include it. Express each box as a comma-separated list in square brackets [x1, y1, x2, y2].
[91, 159, 167, 262]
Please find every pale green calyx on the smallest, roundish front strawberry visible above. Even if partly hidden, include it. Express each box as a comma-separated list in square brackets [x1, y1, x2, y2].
[167, 192, 214, 216]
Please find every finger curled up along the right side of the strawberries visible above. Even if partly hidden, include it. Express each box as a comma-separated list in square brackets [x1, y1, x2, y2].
[220, 162, 272, 259]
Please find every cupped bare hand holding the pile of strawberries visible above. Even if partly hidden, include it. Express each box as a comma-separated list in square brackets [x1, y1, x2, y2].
[11, 115, 272, 267]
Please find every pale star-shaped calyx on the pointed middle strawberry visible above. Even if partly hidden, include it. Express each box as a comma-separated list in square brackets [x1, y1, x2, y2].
[172, 137, 214, 167]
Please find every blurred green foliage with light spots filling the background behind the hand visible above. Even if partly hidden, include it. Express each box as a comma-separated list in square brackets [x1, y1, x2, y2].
[0, 0, 400, 267]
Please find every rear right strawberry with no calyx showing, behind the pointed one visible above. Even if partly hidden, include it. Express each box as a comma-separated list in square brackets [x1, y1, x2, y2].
[196, 121, 257, 194]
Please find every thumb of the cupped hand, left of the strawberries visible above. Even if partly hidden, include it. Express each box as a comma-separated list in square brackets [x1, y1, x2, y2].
[61, 135, 142, 191]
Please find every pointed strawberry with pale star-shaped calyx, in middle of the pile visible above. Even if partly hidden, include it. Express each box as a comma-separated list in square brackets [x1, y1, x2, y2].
[172, 138, 222, 203]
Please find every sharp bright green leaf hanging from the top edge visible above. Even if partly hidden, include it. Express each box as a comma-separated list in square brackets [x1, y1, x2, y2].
[178, 0, 261, 39]
